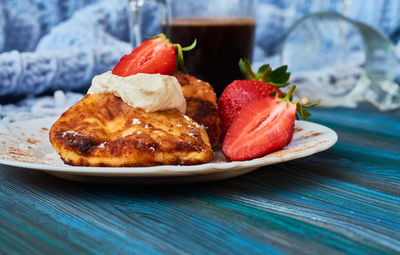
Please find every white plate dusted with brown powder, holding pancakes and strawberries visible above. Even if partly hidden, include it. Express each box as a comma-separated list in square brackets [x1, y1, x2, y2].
[0, 118, 337, 184]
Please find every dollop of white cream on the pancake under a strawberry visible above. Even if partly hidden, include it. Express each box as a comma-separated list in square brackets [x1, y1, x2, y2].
[87, 71, 186, 114]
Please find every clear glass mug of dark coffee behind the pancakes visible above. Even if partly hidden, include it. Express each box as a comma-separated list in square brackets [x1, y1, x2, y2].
[131, 0, 257, 96]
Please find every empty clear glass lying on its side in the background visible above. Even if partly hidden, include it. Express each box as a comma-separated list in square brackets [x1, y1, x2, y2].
[281, 12, 400, 110]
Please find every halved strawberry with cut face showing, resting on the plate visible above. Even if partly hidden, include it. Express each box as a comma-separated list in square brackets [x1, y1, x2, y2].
[222, 86, 319, 161]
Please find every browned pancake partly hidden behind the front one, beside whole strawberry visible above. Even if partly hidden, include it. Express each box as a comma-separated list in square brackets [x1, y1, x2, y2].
[175, 73, 221, 147]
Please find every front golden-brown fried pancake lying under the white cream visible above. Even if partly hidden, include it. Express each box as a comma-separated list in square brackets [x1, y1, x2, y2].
[50, 94, 213, 167]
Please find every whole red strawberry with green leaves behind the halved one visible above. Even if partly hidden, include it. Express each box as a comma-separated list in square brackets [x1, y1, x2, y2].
[218, 59, 290, 136]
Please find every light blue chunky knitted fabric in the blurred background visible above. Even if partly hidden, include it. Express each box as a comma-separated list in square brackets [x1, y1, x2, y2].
[0, 0, 400, 120]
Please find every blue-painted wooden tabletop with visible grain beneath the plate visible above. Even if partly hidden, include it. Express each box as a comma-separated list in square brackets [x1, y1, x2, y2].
[0, 106, 400, 255]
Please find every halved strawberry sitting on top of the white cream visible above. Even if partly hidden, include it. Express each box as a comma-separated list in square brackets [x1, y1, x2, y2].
[112, 34, 196, 76]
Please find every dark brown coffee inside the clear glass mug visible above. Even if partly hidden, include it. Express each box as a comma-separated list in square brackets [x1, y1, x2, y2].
[162, 18, 255, 96]
